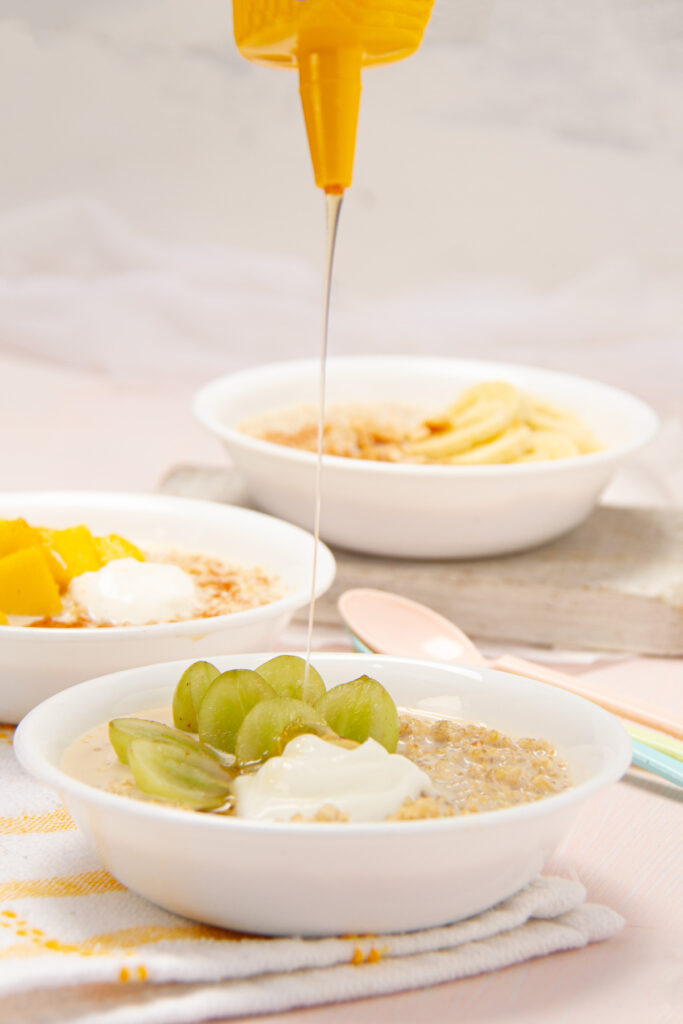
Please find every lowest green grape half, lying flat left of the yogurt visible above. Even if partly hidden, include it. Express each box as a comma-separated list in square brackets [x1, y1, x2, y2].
[128, 739, 231, 811]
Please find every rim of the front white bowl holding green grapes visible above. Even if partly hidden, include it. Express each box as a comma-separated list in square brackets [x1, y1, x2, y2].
[13, 651, 633, 839]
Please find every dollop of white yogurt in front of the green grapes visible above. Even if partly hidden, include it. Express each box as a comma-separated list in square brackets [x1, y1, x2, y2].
[229, 733, 434, 821]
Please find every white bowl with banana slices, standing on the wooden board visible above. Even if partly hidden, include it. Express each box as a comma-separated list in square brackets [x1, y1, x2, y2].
[195, 356, 657, 558]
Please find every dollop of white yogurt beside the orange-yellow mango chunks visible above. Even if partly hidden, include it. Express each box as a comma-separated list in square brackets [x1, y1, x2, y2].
[69, 558, 199, 626]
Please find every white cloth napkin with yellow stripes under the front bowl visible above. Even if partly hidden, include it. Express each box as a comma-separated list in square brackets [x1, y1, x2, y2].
[0, 726, 624, 1024]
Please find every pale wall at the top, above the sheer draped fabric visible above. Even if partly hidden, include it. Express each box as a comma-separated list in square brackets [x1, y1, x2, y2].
[0, 0, 683, 292]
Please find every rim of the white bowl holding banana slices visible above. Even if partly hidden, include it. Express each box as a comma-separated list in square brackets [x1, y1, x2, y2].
[193, 355, 659, 479]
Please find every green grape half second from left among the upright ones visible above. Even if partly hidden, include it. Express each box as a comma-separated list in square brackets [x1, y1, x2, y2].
[197, 669, 278, 754]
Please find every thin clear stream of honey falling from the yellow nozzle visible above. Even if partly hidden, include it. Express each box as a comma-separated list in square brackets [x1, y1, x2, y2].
[304, 193, 343, 683]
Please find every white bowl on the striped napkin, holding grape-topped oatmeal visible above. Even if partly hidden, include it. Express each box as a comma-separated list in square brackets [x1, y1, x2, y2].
[14, 653, 631, 935]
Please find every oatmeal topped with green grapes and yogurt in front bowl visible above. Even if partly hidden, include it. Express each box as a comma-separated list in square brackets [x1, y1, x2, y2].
[62, 654, 570, 823]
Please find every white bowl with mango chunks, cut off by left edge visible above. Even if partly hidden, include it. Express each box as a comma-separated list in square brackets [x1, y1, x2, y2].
[0, 492, 335, 722]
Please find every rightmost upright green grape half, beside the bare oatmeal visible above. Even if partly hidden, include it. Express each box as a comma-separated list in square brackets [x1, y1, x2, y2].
[315, 676, 398, 754]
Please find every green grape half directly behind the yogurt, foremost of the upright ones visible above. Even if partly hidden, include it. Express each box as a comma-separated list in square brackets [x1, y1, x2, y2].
[234, 697, 329, 765]
